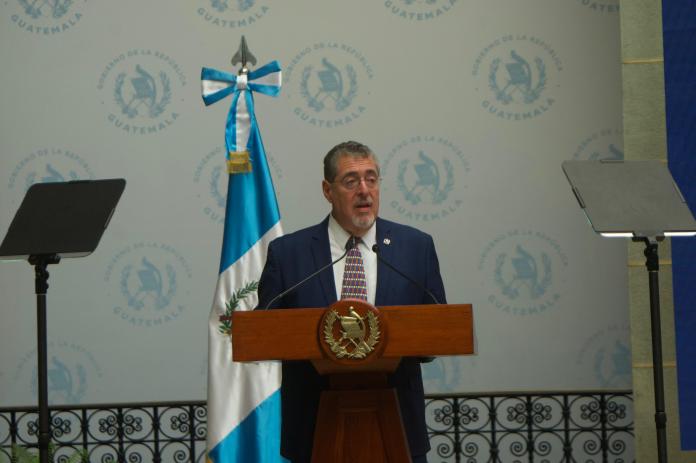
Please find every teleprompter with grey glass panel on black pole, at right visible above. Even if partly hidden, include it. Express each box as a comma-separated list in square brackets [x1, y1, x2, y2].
[563, 161, 696, 463]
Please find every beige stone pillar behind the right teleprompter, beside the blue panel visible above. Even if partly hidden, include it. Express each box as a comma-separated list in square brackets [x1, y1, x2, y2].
[621, 0, 696, 463]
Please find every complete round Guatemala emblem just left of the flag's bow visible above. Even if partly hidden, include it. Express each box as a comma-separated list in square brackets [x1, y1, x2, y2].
[97, 49, 186, 135]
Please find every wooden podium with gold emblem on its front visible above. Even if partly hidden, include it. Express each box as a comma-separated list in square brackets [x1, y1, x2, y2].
[232, 299, 474, 463]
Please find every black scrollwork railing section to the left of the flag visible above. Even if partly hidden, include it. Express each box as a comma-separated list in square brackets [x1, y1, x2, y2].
[0, 401, 207, 463]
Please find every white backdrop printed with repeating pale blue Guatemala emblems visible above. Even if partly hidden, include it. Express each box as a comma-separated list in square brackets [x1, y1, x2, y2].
[0, 0, 631, 405]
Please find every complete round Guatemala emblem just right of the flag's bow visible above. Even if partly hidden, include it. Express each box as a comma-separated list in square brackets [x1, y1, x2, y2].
[284, 42, 374, 128]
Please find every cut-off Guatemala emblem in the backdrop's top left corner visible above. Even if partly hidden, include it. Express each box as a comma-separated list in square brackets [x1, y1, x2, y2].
[3, 0, 87, 37]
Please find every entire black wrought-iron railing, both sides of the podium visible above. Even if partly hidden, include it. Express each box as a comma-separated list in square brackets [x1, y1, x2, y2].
[0, 391, 635, 463]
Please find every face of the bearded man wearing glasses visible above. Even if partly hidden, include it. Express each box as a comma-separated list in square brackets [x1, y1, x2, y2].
[321, 155, 379, 236]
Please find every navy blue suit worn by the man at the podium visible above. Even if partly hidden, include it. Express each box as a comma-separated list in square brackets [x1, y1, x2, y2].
[258, 217, 446, 463]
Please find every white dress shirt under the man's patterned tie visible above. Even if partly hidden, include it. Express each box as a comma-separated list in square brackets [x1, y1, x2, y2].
[329, 215, 377, 305]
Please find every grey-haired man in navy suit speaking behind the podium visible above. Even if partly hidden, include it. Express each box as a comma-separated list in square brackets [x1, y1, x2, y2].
[258, 141, 446, 463]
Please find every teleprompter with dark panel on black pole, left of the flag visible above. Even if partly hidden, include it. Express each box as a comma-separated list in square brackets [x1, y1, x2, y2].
[0, 179, 126, 463]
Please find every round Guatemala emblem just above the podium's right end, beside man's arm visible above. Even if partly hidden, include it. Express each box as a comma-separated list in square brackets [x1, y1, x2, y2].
[478, 230, 568, 316]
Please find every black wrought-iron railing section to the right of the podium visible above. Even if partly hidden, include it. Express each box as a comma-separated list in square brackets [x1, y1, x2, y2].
[426, 391, 635, 463]
